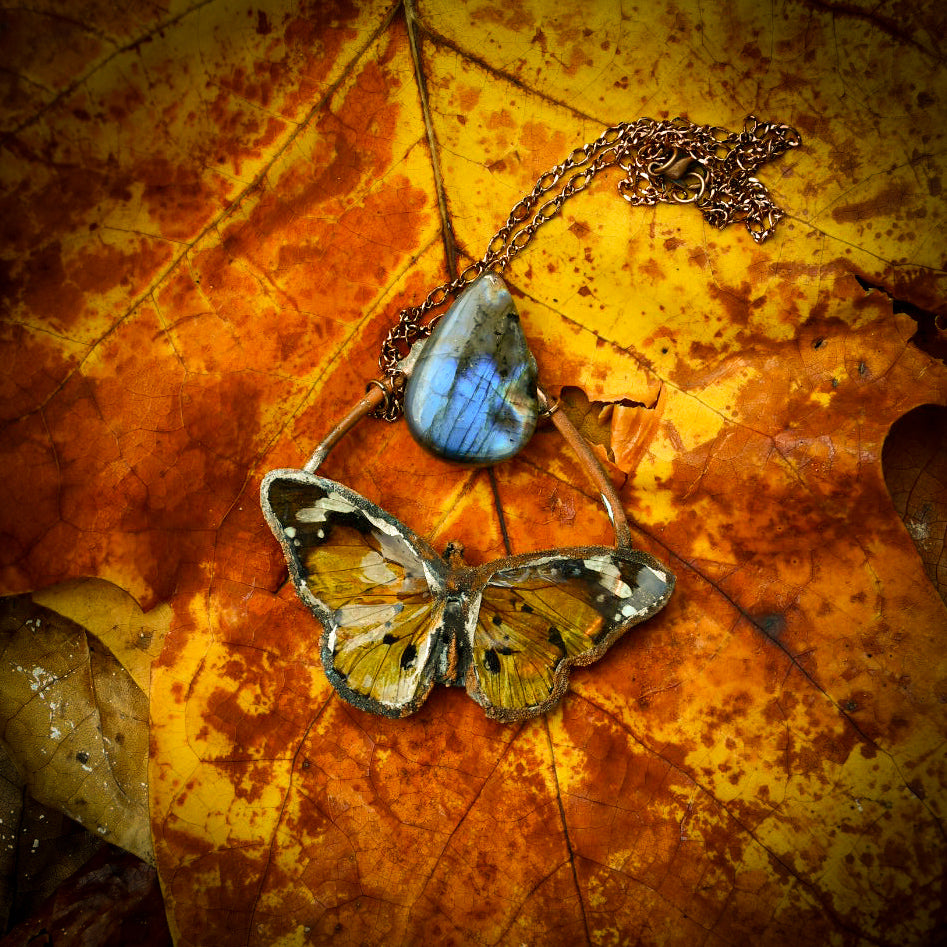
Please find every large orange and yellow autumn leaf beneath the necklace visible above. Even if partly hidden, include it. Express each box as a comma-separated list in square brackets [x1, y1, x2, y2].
[0, 0, 947, 944]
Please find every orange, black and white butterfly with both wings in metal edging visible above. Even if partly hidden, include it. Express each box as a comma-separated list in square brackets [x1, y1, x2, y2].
[261, 469, 674, 721]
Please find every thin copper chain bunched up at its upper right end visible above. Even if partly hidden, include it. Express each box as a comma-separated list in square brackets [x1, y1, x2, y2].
[374, 116, 802, 421]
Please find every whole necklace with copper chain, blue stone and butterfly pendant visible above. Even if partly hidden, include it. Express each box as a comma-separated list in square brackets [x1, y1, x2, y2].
[261, 117, 801, 721]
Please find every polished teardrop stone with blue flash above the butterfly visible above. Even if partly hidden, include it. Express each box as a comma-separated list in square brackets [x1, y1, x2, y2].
[404, 273, 539, 465]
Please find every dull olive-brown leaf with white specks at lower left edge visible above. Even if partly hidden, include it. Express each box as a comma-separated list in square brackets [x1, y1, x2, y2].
[0, 595, 153, 862]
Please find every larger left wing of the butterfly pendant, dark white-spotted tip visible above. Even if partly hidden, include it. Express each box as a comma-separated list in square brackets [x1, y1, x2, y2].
[260, 470, 447, 717]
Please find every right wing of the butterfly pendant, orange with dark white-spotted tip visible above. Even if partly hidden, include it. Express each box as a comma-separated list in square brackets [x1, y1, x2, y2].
[467, 547, 674, 720]
